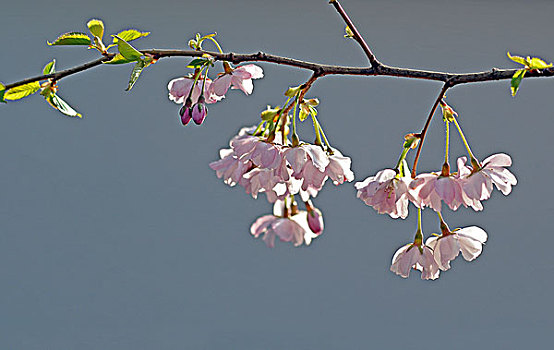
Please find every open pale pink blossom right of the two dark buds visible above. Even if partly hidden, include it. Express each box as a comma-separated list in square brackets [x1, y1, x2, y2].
[209, 64, 264, 96]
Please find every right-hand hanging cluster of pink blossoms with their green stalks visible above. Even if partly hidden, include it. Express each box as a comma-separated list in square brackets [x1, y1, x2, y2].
[355, 101, 517, 279]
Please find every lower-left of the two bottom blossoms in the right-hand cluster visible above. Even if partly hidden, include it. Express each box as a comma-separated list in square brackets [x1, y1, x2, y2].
[390, 243, 440, 280]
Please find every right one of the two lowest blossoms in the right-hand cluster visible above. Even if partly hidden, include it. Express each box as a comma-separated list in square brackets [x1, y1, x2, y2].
[425, 226, 487, 271]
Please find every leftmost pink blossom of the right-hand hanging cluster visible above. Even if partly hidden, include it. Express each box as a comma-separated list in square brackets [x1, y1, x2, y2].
[354, 169, 411, 219]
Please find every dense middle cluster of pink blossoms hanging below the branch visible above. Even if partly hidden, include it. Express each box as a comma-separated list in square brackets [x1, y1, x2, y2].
[210, 127, 354, 247]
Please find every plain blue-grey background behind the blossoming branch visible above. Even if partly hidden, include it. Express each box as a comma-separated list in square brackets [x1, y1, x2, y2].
[0, 0, 554, 349]
